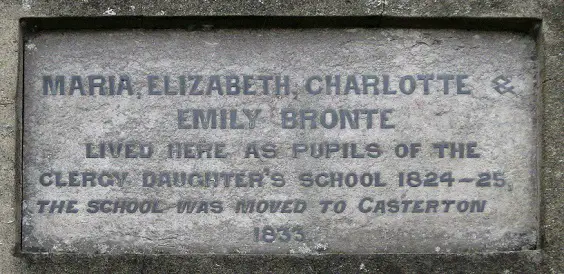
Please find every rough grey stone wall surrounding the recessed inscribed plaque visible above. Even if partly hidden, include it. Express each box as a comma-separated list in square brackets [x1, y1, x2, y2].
[0, 0, 564, 273]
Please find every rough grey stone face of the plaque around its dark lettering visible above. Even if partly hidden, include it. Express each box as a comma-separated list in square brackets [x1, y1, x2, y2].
[23, 29, 538, 254]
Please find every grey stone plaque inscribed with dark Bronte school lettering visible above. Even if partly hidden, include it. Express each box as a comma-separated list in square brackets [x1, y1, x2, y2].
[22, 29, 539, 254]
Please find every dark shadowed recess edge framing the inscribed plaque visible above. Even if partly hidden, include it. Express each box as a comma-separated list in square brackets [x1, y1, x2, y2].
[15, 16, 543, 257]
